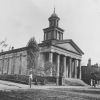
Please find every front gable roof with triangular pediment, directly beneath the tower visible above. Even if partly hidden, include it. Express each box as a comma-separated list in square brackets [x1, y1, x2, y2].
[39, 39, 84, 55]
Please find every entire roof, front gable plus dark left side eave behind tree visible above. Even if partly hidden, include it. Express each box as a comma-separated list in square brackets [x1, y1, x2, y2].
[0, 39, 84, 55]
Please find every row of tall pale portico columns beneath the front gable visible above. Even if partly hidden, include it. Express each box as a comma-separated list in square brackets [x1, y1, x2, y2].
[48, 52, 81, 79]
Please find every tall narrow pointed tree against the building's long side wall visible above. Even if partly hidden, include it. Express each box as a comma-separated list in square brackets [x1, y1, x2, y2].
[27, 37, 39, 71]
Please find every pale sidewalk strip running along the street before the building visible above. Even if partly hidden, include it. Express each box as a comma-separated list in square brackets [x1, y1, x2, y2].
[0, 80, 100, 91]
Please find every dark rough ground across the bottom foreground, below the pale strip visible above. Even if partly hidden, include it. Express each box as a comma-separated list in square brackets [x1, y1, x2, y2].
[0, 89, 100, 100]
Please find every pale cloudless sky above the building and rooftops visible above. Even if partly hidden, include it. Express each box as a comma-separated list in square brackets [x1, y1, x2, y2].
[0, 0, 100, 65]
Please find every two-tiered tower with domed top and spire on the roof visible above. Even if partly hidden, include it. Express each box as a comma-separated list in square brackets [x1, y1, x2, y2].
[43, 8, 64, 41]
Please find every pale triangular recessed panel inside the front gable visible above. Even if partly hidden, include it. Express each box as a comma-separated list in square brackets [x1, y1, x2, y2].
[56, 43, 80, 54]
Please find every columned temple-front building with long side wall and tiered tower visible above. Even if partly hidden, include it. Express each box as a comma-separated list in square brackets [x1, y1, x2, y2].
[0, 11, 84, 84]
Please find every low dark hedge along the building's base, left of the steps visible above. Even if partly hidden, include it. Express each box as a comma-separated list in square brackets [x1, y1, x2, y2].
[0, 74, 56, 85]
